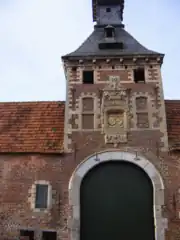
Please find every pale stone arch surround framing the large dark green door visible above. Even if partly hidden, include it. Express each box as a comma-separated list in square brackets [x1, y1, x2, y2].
[69, 150, 167, 240]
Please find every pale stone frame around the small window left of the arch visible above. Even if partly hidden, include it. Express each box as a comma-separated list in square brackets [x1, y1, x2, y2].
[28, 180, 52, 212]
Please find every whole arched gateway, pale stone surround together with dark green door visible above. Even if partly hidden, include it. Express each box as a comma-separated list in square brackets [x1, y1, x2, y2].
[69, 151, 165, 240]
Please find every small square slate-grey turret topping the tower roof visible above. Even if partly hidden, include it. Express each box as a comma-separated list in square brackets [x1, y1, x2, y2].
[92, 0, 124, 25]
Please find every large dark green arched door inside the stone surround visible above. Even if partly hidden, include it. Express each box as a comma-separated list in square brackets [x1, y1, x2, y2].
[80, 161, 155, 240]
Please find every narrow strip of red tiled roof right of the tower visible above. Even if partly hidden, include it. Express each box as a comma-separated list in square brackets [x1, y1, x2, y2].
[165, 100, 180, 148]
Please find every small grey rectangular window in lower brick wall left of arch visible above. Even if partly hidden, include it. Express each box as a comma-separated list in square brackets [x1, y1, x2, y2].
[35, 184, 48, 209]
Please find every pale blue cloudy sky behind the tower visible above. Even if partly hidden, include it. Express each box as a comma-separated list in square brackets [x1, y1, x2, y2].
[0, 0, 180, 102]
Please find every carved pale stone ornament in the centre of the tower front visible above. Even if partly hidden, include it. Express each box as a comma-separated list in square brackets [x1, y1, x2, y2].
[101, 76, 128, 147]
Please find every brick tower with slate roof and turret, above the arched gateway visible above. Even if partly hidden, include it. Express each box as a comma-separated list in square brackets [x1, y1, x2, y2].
[62, 0, 168, 156]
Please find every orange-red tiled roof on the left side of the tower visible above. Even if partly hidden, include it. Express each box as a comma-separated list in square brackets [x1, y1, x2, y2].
[0, 102, 65, 153]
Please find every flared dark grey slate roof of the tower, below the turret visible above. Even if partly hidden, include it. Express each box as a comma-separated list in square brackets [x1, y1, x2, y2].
[62, 26, 163, 58]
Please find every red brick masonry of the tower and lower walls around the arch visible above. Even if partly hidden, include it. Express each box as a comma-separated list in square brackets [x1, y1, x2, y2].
[0, 58, 177, 240]
